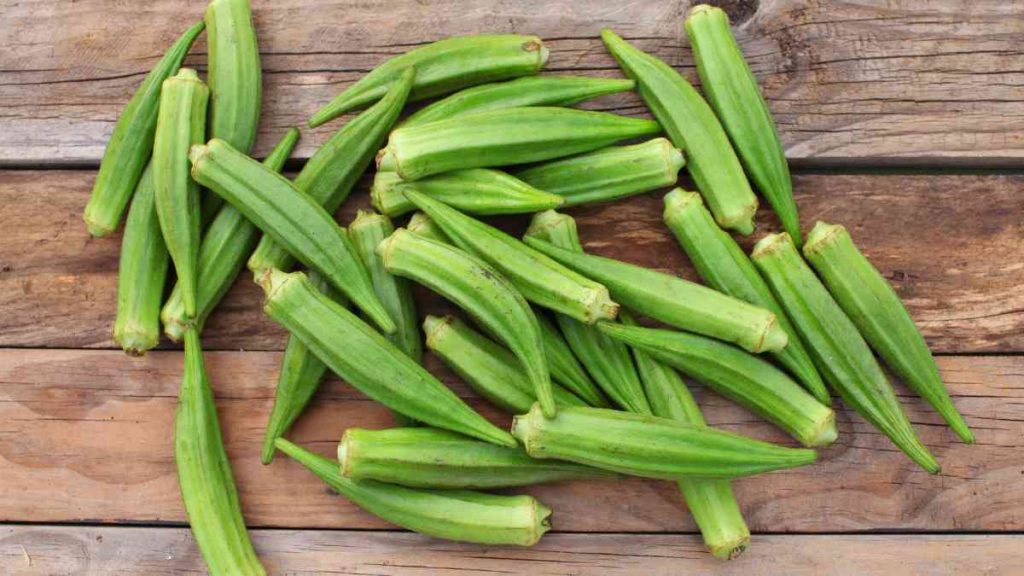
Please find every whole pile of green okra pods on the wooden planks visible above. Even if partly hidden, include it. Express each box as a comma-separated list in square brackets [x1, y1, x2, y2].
[85, 0, 974, 575]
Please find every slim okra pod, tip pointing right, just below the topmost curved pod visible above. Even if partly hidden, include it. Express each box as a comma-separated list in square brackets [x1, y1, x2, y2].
[401, 75, 636, 126]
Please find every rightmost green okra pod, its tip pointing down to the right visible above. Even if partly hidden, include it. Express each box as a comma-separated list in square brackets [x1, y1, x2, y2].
[804, 222, 974, 444]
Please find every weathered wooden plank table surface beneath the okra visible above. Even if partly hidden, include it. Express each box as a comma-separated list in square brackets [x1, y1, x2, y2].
[0, 0, 1024, 575]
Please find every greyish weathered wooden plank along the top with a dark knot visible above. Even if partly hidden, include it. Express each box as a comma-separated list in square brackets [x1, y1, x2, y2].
[0, 0, 1024, 166]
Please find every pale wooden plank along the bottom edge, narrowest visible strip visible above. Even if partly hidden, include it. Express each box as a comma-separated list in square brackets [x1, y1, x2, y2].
[0, 526, 1024, 576]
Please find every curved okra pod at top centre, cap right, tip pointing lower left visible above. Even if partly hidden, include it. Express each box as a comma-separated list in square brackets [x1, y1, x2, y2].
[309, 34, 548, 127]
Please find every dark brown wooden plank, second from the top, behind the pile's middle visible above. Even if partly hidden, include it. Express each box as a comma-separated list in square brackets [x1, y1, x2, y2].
[0, 170, 1024, 354]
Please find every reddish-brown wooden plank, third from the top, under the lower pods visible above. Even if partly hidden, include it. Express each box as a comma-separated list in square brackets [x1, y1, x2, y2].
[0, 349, 1024, 532]
